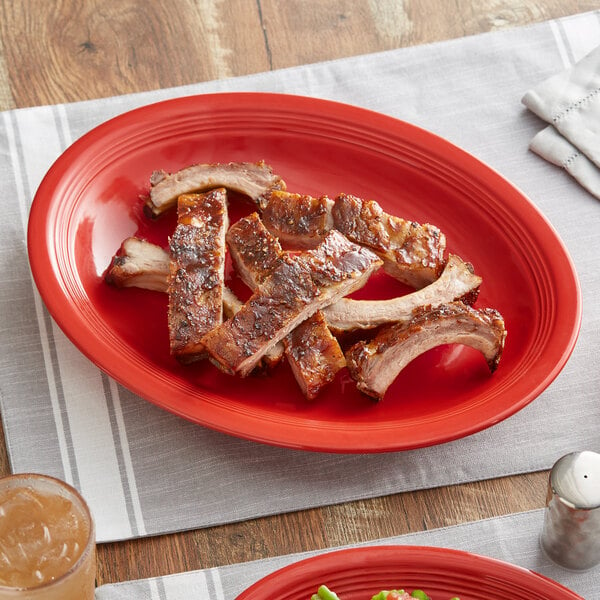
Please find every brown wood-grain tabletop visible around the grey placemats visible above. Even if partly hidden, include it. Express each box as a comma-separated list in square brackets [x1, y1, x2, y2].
[0, 0, 599, 584]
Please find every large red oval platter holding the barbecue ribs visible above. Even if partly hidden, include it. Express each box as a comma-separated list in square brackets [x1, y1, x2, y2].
[28, 93, 581, 452]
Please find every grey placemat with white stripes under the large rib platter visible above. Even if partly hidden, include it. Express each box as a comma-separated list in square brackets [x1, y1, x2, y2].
[0, 12, 600, 541]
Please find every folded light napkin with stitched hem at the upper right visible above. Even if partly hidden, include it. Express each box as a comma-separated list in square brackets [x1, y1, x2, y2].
[522, 46, 600, 198]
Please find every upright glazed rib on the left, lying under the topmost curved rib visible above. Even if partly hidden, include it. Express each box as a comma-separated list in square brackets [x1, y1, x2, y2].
[168, 188, 228, 362]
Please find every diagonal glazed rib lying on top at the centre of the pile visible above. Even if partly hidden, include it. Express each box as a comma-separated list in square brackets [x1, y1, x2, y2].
[202, 231, 381, 376]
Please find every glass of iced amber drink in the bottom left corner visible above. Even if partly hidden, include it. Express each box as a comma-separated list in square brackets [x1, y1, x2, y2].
[0, 474, 96, 600]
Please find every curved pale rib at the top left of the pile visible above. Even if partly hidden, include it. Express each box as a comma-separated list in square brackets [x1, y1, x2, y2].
[145, 161, 285, 217]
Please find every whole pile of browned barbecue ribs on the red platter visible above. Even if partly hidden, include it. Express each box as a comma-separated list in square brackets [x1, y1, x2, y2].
[105, 161, 506, 400]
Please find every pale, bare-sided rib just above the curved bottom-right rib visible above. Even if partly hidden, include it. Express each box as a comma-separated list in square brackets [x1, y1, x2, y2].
[323, 254, 481, 334]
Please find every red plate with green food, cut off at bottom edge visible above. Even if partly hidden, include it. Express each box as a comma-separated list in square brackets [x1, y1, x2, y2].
[236, 546, 583, 600]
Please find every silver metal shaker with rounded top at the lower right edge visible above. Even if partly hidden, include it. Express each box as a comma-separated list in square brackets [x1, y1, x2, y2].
[540, 451, 600, 571]
